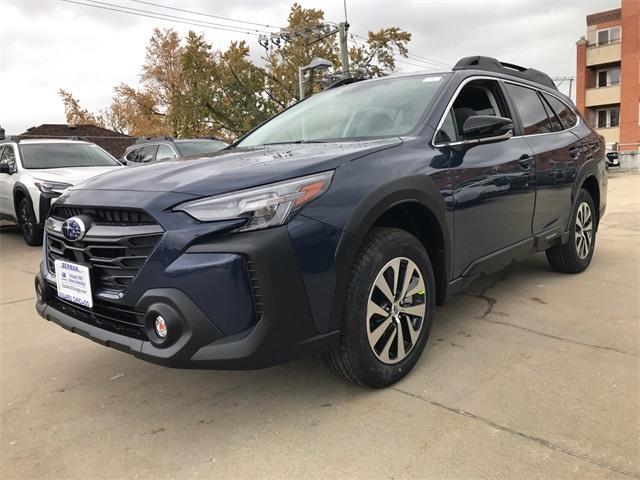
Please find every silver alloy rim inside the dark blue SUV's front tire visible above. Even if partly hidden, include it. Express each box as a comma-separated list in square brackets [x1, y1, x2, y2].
[366, 257, 427, 364]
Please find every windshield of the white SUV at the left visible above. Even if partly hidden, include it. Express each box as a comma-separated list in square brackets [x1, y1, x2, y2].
[20, 143, 120, 169]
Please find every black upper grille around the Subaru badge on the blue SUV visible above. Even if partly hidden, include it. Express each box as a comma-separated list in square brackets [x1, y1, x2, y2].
[47, 226, 162, 295]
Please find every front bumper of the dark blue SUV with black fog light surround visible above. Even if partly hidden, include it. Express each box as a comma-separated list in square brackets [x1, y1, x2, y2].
[36, 226, 337, 369]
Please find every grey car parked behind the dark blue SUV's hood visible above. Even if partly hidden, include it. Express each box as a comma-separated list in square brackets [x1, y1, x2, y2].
[120, 137, 228, 167]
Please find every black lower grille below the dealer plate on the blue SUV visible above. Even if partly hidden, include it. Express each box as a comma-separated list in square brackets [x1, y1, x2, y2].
[48, 295, 148, 340]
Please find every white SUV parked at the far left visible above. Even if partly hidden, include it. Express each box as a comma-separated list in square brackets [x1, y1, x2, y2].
[0, 139, 122, 245]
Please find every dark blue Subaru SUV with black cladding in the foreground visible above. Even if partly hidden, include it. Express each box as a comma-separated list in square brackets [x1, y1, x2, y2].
[36, 57, 607, 387]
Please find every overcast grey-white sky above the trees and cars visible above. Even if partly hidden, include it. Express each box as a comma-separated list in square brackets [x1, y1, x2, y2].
[0, 0, 620, 134]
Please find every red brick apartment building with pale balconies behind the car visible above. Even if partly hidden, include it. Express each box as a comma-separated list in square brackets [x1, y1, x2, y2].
[576, 0, 640, 151]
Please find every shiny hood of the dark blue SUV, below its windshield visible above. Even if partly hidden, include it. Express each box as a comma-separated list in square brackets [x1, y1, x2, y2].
[75, 138, 402, 196]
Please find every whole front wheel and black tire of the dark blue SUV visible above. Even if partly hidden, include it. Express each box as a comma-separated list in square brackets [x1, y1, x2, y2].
[325, 228, 435, 388]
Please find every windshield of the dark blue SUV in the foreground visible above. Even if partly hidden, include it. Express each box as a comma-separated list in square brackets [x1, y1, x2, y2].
[238, 74, 445, 147]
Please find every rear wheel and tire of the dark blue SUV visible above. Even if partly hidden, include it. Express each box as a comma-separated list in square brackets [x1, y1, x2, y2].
[545, 189, 598, 273]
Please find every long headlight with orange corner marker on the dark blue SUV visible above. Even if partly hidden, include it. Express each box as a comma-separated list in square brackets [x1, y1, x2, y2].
[174, 172, 333, 232]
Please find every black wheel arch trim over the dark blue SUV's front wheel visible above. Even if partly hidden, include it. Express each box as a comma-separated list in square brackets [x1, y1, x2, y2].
[330, 175, 451, 330]
